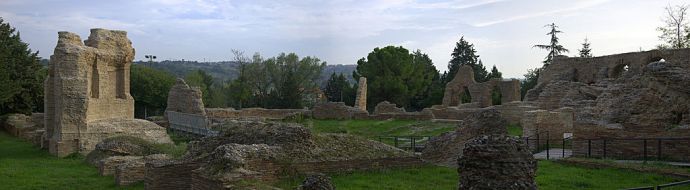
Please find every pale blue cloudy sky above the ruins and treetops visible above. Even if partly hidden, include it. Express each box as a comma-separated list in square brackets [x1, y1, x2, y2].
[0, 0, 683, 77]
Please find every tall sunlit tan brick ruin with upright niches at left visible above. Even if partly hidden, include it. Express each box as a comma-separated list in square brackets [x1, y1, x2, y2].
[45, 29, 171, 156]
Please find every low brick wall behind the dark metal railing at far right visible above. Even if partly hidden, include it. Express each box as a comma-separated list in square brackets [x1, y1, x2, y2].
[573, 124, 690, 162]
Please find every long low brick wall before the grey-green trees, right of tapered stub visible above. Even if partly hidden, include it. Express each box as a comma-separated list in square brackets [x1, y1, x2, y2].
[206, 108, 311, 119]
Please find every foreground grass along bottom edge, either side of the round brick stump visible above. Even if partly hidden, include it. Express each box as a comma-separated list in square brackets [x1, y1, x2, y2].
[275, 161, 690, 190]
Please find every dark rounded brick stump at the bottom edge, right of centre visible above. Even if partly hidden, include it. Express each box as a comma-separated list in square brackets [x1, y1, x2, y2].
[458, 135, 537, 190]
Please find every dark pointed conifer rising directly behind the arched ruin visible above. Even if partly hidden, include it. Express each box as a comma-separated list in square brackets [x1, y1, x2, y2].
[444, 36, 488, 83]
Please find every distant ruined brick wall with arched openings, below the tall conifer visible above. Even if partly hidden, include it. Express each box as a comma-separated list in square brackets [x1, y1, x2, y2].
[442, 65, 520, 108]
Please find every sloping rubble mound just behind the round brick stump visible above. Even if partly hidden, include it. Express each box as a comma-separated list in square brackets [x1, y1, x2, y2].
[422, 109, 508, 167]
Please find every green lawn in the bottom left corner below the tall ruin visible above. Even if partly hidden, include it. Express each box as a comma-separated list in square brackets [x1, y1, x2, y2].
[0, 130, 144, 189]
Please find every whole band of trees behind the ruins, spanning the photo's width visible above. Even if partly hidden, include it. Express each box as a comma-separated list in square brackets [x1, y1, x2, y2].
[0, 5, 690, 117]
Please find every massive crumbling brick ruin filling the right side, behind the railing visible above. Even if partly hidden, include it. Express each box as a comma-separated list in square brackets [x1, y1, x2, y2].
[525, 49, 690, 161]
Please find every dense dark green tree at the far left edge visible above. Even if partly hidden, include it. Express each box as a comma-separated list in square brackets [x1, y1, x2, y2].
[0, 18, 46, 114]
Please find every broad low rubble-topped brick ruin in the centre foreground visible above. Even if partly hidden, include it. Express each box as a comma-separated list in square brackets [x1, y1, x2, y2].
[146, 121, 424, 189]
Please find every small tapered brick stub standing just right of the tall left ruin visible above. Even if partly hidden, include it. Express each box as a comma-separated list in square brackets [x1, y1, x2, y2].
[165, 78, 206, 115]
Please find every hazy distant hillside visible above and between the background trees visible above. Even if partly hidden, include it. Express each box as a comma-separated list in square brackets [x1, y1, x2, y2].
[134, 60, 357, 85]
